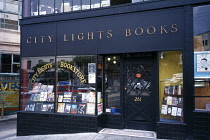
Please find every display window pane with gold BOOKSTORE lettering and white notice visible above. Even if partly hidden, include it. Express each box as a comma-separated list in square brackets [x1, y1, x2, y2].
[56, 56, 96, 115]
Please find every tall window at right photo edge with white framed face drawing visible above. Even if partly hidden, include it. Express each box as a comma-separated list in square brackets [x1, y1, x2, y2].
[193, 5, 210, 111]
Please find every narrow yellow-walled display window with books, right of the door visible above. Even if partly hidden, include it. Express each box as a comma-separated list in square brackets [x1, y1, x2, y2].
[159, 51, 183, 123]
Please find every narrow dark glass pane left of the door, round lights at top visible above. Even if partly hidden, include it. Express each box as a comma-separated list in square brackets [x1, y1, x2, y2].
[105, 56, 120, 113]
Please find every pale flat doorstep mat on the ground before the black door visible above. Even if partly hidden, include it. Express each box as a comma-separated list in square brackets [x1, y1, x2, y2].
[98, 128, 156, 139]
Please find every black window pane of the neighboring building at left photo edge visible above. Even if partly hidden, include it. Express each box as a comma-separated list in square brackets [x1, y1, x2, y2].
[1, 54, 12, 73]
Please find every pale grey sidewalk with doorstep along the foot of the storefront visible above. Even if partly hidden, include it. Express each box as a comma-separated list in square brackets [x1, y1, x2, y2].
[0, 115, 161, 140]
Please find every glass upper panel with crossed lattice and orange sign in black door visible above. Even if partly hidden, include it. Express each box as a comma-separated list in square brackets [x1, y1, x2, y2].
[126, 64, 151, 96]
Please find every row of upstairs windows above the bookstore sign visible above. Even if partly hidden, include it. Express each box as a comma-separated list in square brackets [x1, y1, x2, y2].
[23, 0, 164, 17]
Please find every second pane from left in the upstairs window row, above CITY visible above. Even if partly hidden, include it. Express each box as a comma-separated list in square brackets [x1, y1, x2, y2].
[39, 0, 54, 15]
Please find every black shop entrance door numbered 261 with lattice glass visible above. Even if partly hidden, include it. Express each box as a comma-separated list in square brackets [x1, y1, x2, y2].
[124, 60, 158, 131]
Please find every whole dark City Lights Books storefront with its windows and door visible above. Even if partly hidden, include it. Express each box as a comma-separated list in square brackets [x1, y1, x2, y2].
[17, 0, 210, 139]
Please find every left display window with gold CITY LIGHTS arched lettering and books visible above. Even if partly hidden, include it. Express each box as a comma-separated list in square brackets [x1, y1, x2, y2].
[21, 57, 55, 112]
